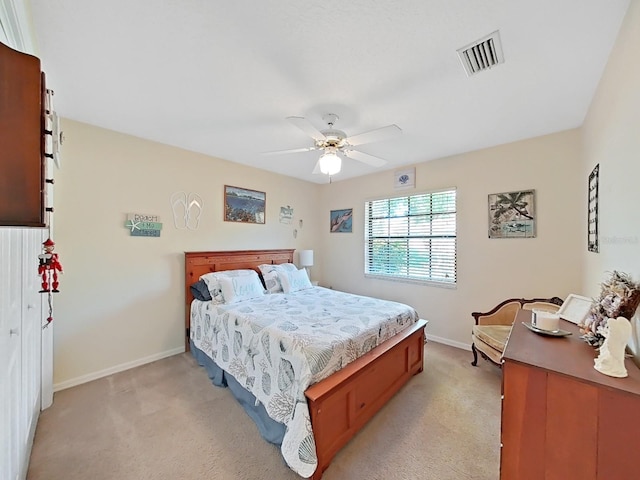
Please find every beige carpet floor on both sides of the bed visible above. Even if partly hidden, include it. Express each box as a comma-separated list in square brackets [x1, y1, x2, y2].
[27, 342, 501, 480]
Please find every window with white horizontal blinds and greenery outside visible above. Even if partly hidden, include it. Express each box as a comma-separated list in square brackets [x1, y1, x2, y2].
[364, 189, 456, 285]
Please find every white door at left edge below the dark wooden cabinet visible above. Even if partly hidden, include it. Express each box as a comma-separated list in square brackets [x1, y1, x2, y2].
[0, 228, 46, 480]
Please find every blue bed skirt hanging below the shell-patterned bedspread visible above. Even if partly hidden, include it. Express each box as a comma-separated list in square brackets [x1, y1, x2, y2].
[190, 341, 286, 446]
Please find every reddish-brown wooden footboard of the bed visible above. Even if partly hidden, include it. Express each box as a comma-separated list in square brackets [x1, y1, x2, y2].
[305, 320, 427, 480]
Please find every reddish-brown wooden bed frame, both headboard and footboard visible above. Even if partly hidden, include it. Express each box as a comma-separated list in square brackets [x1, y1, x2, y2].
[185, 250, 427, 480]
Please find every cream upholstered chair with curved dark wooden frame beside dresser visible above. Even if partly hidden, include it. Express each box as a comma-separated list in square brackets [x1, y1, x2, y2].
[471, 297, 562, 367]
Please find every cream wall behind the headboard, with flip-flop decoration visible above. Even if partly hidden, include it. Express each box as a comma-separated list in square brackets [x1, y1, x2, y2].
[54, 120, 320, 389]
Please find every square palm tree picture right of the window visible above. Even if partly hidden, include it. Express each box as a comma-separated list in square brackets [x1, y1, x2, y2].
[489, 190, 536, 238]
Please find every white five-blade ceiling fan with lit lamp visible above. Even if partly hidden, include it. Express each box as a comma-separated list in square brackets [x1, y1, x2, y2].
[267, 113, 402, 175]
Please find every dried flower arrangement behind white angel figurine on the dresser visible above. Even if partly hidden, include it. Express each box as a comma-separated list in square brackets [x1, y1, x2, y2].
[579, 270, 640, 347]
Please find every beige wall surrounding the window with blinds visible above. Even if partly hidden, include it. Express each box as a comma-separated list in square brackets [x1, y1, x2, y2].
[321, 130, 584, 347]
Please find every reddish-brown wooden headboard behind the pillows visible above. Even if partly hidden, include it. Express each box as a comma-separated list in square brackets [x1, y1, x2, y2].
[184, 249, 294, 352]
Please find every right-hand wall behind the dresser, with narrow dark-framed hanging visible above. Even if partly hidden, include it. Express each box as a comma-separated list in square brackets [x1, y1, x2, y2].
[580, 1, 640, 353]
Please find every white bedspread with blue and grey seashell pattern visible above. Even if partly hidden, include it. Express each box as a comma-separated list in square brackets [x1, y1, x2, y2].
[190, 287, 418, 477]
